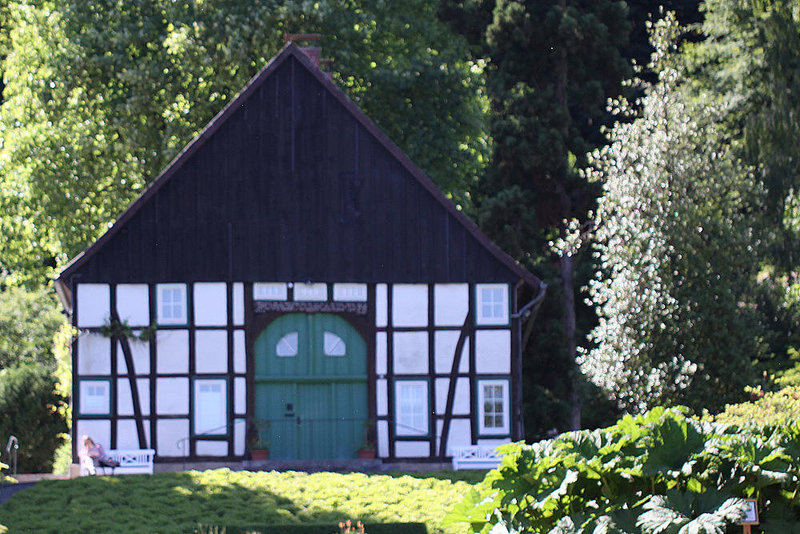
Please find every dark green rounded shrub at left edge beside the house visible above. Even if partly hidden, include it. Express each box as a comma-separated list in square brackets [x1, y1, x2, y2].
[0, 364, 67, 473]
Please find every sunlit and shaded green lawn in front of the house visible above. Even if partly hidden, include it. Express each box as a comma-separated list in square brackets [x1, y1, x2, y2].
[0, 469, 480, 534]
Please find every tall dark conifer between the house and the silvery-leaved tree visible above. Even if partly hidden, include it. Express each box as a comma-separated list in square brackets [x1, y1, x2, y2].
[440, 0, 630, 428]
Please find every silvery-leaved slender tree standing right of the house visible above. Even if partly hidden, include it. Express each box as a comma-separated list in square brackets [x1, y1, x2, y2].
[581, 12, 764, 412]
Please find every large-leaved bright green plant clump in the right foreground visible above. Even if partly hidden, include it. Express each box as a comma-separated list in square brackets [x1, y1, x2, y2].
[447, 408, 800, 534]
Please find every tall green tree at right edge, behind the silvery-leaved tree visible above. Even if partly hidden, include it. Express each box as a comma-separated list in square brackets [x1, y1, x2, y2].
[685, 0, 800, 382]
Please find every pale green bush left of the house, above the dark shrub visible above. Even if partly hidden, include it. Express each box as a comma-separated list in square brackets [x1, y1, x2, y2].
[0, 287, 66, 371]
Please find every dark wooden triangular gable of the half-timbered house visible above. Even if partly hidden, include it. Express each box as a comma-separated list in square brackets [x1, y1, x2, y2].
[59, 44, 538, 292]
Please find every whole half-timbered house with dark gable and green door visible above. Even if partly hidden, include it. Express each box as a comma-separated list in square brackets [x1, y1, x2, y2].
[56, 44, 544, 462]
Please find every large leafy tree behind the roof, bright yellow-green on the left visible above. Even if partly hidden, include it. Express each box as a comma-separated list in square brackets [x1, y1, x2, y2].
[0, 0, 486, 283]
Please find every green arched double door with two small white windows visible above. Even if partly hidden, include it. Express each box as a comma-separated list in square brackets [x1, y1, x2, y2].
[254, 313, 368, 460]
